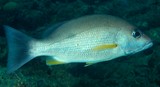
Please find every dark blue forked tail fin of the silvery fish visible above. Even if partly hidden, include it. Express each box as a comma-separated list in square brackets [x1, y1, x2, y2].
[4, 26, 33, 73]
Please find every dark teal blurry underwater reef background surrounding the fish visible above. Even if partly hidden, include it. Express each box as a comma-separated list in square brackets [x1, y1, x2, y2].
[0, 0, 160, 87]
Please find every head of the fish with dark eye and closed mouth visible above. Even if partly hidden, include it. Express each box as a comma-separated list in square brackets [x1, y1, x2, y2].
[116, 27, 153, 55]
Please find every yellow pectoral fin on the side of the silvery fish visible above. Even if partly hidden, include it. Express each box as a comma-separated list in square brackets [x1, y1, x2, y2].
[93, 44, 117, 51]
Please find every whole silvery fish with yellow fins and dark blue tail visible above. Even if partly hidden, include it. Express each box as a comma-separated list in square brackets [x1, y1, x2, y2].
[4, 14, 153, 73]
